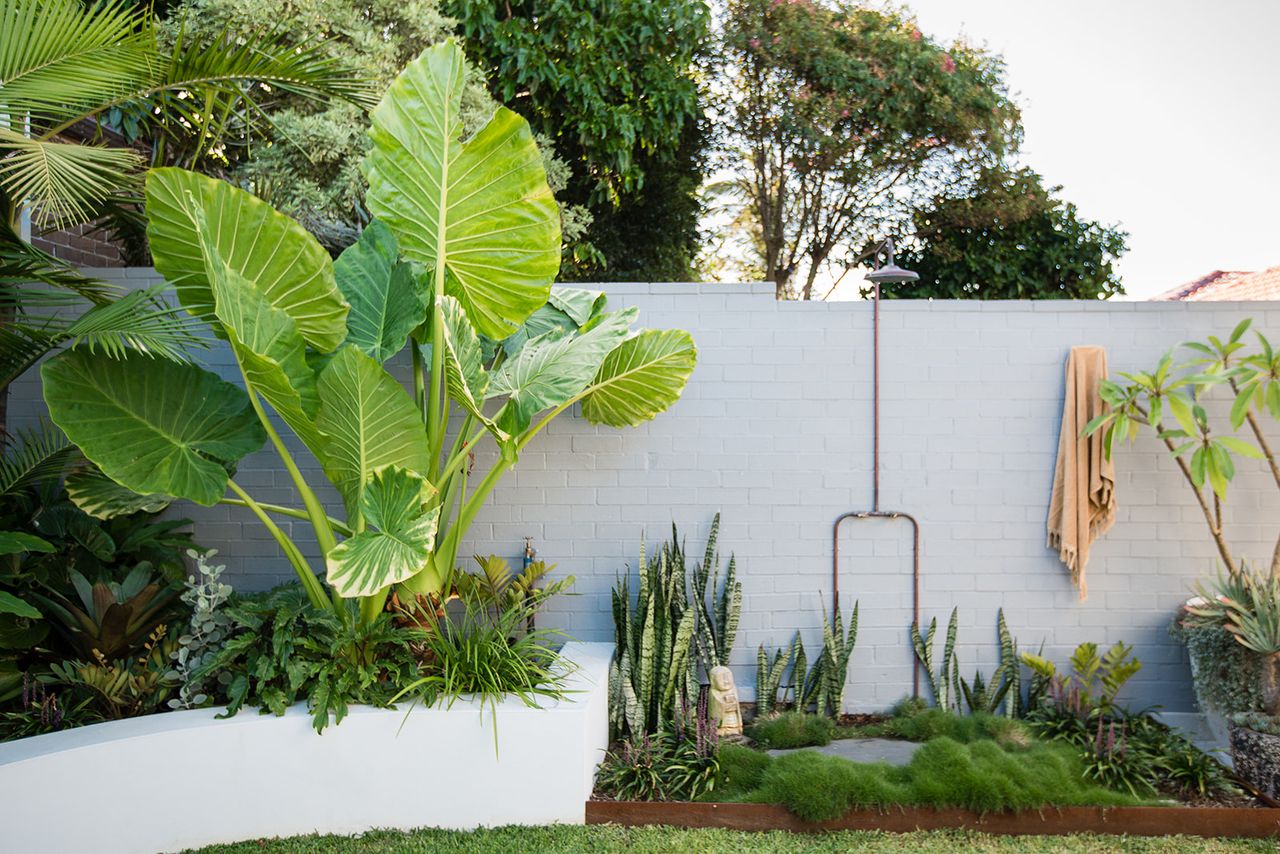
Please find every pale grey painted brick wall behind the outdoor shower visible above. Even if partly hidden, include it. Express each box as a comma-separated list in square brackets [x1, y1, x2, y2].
[13, 270, 1280, 711]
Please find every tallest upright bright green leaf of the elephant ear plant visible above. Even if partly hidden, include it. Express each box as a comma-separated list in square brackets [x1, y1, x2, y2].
[365, 40, 561, 339]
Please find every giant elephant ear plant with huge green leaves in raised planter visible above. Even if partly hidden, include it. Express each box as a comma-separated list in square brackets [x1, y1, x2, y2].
[41, 42, 695, 635]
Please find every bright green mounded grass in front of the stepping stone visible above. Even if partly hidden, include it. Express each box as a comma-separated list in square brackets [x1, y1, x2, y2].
[716, 736, 1146, 822]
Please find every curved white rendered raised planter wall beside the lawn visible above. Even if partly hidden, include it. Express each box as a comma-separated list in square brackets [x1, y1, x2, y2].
[0, 643, 613, 854]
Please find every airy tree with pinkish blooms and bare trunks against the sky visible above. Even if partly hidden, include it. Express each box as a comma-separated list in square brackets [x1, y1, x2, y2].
[717, 0, 1020, 300]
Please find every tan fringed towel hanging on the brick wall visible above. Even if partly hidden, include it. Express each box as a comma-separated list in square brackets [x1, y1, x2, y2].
[1048, 347, 1116, 600]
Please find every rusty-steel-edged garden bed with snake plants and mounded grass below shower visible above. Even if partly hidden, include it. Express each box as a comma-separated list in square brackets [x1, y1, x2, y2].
[599, 525, 1280, 835]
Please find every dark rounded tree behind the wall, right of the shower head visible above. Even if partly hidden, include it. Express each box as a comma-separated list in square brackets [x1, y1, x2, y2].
[881, 169, 1126, 300]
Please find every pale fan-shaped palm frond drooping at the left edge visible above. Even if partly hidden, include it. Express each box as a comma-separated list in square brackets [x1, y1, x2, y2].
[0, 126, 142, 225]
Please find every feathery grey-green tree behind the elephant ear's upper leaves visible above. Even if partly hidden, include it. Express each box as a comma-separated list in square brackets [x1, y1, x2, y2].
[168, 0, 590, 257]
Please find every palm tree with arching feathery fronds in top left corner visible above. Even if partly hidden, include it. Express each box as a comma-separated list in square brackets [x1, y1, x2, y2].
[0, 0, 371, 428]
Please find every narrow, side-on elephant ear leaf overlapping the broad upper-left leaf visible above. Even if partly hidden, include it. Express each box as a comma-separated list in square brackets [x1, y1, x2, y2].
[195, 210, 323, 456]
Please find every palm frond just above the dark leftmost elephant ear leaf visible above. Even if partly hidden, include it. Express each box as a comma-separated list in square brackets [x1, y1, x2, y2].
[64, 286, 209, 362]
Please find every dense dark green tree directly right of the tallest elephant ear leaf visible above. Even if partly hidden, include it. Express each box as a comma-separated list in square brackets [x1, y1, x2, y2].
[444, 0, 709, 280]
